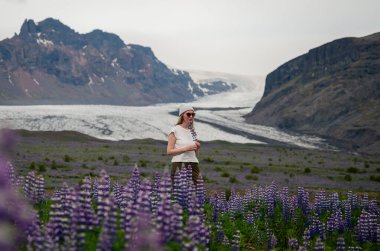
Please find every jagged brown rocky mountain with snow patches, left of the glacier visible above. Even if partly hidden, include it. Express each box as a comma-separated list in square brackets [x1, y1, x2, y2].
[0, 18, 236, 105]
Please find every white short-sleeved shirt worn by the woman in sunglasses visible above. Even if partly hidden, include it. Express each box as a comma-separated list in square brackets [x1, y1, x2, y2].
[169, 125, 199, 163]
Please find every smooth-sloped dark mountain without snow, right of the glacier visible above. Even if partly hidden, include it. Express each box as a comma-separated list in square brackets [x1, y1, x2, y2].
[245, 33, 380, 154]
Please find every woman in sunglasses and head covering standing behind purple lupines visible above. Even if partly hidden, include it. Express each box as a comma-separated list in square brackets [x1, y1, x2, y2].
[167, 106, 201, 184]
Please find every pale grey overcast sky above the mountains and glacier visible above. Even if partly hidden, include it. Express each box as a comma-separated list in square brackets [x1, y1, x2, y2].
[0, 0, 380, 76]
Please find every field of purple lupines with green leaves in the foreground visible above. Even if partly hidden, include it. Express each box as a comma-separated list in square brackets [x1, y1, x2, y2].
[0, 155, 380, 250]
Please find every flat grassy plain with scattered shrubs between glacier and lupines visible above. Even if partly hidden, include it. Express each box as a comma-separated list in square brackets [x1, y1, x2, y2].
[11, 128, 380, 193]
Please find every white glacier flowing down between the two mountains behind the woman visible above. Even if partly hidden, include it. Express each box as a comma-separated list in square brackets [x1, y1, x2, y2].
[0, 71, 327, 149]
